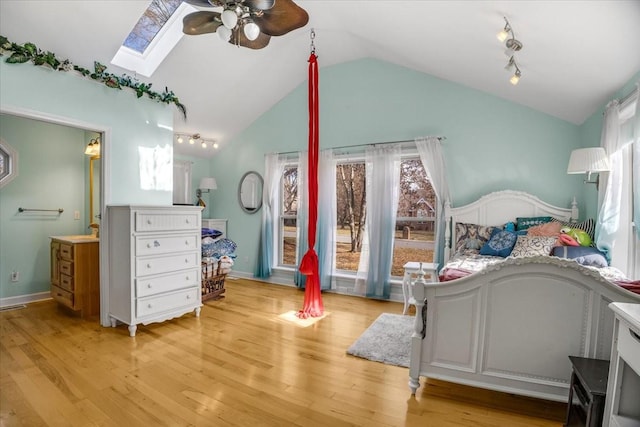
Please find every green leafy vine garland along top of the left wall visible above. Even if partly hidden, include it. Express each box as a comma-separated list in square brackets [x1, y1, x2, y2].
[0, 35, 187, 119]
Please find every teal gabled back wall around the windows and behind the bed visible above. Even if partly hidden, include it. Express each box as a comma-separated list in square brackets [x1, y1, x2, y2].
[212, 58, 584, 273]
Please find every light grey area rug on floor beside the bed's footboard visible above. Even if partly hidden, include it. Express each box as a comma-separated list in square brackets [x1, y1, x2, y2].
[347, 313, 415, 368]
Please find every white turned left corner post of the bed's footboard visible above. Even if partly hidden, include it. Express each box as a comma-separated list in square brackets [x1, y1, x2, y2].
[409, 263, 427, 395]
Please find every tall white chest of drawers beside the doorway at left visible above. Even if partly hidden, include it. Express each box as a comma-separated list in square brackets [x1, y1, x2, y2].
[107, 205, 202, 337]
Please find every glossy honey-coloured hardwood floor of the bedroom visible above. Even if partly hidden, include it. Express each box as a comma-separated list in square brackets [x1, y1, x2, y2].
[0, 279, 565, 427]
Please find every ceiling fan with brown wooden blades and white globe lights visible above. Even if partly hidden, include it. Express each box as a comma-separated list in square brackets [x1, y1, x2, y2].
[182, 0, 309, 49]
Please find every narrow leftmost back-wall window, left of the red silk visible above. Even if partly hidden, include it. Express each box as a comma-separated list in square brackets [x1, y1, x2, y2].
[278, 165, 298, 267]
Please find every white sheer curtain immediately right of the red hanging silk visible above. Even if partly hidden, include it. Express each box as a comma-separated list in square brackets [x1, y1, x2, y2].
[316, 149, 337, 290]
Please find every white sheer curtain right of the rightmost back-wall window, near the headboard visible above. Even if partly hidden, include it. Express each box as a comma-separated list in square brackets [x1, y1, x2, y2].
[415, 136, 451, 266]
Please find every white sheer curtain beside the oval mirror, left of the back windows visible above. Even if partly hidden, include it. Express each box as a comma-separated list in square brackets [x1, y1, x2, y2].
[255, 154, 284, 279]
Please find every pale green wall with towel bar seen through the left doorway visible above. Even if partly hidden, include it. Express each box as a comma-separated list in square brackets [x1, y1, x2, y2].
[0, 115, 88, 297]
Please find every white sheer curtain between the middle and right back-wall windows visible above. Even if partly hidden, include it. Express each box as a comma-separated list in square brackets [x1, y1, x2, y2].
[355, 144, 401, 299]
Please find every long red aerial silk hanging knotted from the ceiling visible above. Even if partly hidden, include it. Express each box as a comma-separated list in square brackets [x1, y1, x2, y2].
[297, 52, 324, 319]
